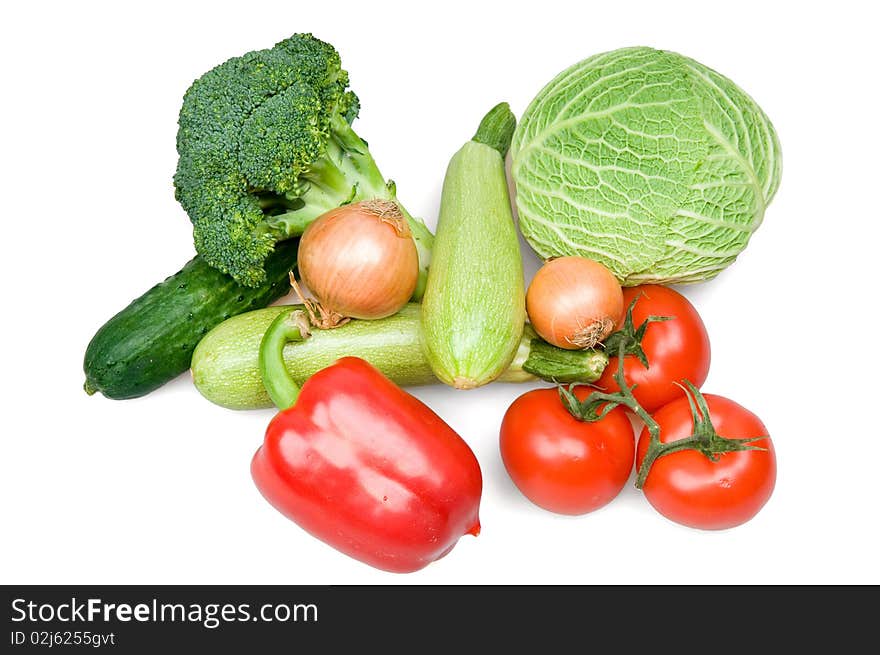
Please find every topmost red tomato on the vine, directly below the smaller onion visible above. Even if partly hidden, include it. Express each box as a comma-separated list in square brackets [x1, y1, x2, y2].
[596, 284, 711, 413]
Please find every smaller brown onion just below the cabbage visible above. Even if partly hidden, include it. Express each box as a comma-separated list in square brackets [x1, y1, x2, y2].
[526, 257, 623, 350]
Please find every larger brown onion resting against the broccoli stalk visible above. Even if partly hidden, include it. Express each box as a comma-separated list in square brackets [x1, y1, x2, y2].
[298, 200, 419, 327]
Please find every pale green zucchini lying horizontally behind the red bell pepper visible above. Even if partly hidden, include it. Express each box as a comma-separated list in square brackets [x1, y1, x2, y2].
[192, 303, 608, 409]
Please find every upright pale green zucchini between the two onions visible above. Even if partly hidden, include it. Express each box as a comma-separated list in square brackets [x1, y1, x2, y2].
[422, 103, 526, 389]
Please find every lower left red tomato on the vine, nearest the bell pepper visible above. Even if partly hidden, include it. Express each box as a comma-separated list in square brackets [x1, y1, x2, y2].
[501, 387, 635, 514]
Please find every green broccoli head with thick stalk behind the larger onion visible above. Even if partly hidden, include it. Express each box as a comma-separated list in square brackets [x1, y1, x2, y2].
[174, 34, 433, 291]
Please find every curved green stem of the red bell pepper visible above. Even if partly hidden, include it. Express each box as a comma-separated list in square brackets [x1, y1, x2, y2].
[260, 308, 310, 409]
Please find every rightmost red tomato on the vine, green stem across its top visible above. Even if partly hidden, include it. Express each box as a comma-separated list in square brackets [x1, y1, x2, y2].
[636, 394, 776, 530]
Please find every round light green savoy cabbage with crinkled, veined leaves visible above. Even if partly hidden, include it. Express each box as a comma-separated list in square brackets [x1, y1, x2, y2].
[511, 48, 782, 285]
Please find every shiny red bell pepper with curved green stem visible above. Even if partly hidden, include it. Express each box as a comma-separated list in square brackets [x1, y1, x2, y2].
[251, 311, 482, 573]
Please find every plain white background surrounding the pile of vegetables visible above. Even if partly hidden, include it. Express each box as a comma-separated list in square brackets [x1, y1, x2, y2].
[0, 0, 880, 584]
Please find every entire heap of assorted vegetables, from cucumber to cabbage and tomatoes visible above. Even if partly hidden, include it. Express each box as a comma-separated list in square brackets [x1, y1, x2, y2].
[84, 35, 781, 572]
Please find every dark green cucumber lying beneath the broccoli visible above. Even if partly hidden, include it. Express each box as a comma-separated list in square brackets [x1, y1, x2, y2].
[83, 239, 298, 400]
